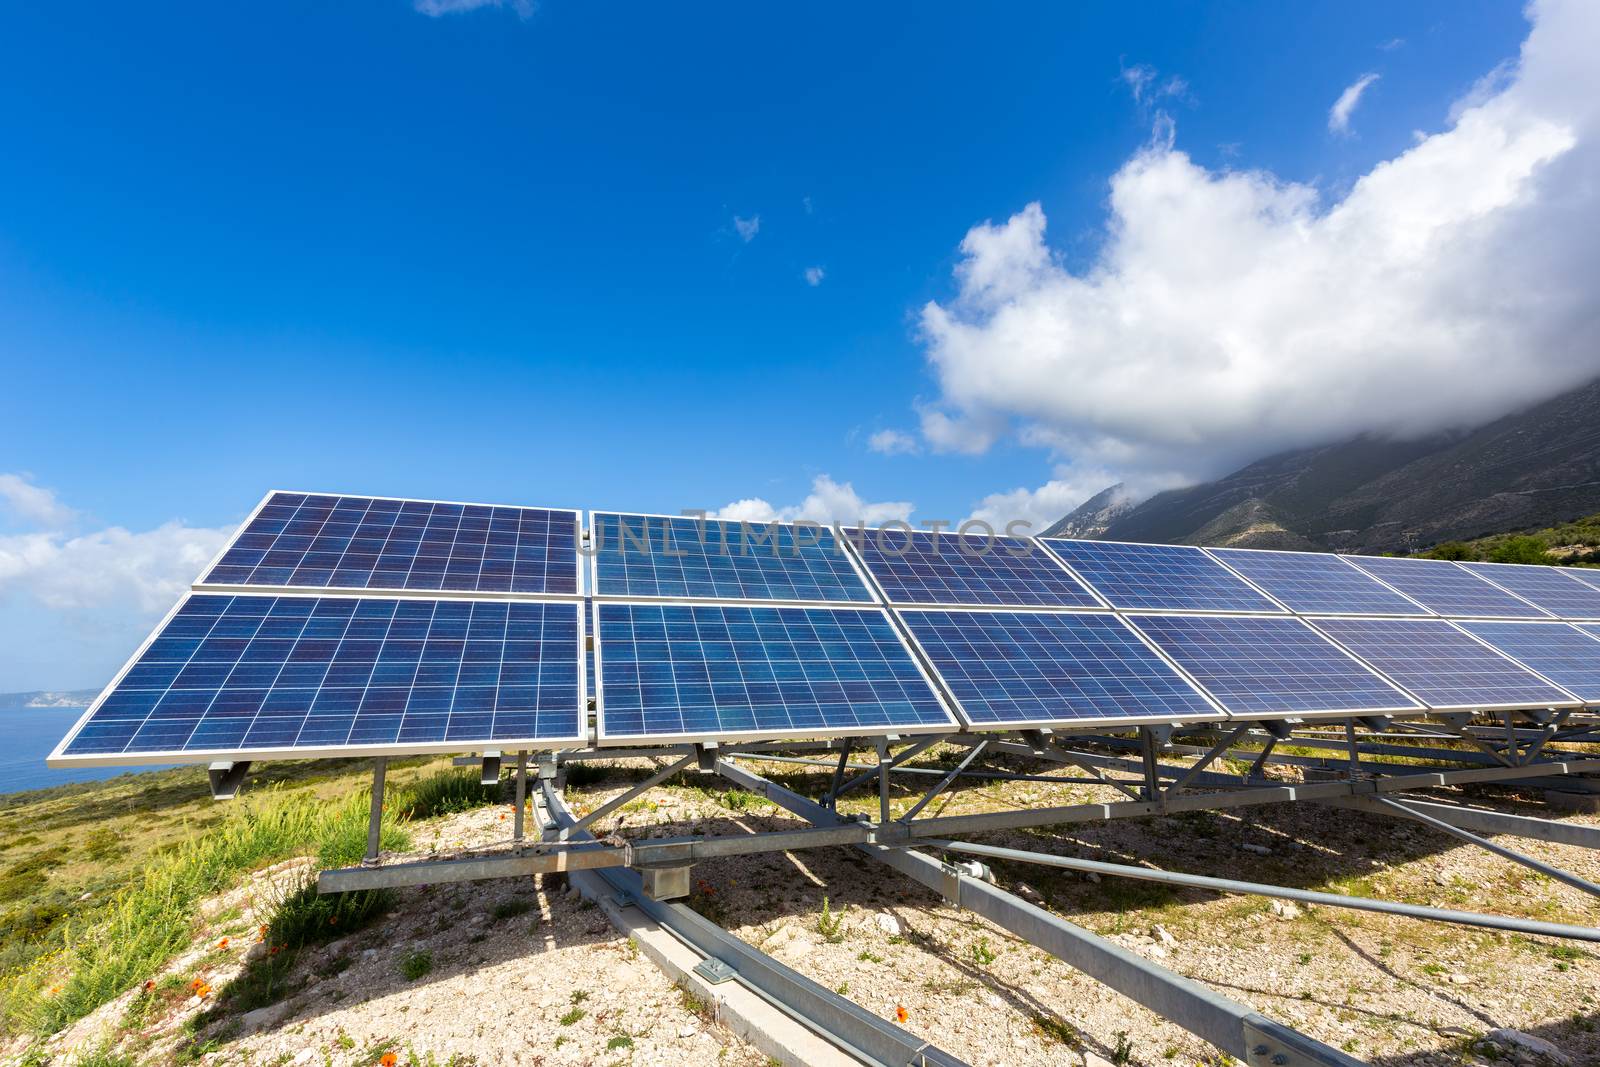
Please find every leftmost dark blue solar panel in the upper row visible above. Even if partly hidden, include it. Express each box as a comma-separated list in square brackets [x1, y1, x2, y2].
[200, 493, 578, 593]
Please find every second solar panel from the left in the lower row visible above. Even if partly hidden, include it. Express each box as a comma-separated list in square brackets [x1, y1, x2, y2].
[595, 601, 955, 742]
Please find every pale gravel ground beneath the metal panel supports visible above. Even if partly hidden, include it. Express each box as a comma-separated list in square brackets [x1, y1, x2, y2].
[15, 751, 1600, 1067]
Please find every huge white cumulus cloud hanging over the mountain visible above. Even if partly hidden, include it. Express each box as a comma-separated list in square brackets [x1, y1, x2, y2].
[920, 0, 1600, 518]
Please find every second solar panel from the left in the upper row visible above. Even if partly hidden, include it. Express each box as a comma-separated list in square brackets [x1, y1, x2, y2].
[594, 512, 872, 603]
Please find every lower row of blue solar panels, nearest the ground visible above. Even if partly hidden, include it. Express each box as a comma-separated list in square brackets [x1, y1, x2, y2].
[58, 593, 1600, 761]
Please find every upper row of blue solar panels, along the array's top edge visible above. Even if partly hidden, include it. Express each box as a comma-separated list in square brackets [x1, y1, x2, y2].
[197, 493, 1600, 621]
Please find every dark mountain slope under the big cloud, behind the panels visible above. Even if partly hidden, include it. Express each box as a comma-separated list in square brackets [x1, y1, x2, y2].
[1051, 381, 1600, 552]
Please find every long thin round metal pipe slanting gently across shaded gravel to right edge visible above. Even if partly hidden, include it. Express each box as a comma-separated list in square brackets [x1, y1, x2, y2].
[925, 841, 1600, 942]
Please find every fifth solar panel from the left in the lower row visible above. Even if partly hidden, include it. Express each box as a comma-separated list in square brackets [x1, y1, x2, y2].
[1314, 619, 1573, 709]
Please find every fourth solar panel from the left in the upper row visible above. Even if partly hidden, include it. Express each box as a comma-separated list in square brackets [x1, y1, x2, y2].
[1045, 537, 1283, 613]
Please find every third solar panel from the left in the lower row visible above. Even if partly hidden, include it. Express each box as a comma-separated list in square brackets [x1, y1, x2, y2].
[899, 609, 1209, 726]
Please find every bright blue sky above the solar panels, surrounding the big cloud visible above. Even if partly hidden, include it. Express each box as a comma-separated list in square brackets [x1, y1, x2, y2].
[0, 0, 1576, 689]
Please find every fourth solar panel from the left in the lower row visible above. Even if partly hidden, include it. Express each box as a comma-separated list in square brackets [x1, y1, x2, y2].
[1128, 614, 1421, 715]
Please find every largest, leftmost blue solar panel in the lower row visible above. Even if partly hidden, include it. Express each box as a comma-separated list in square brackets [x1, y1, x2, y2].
[51, 593, 584, 763]
